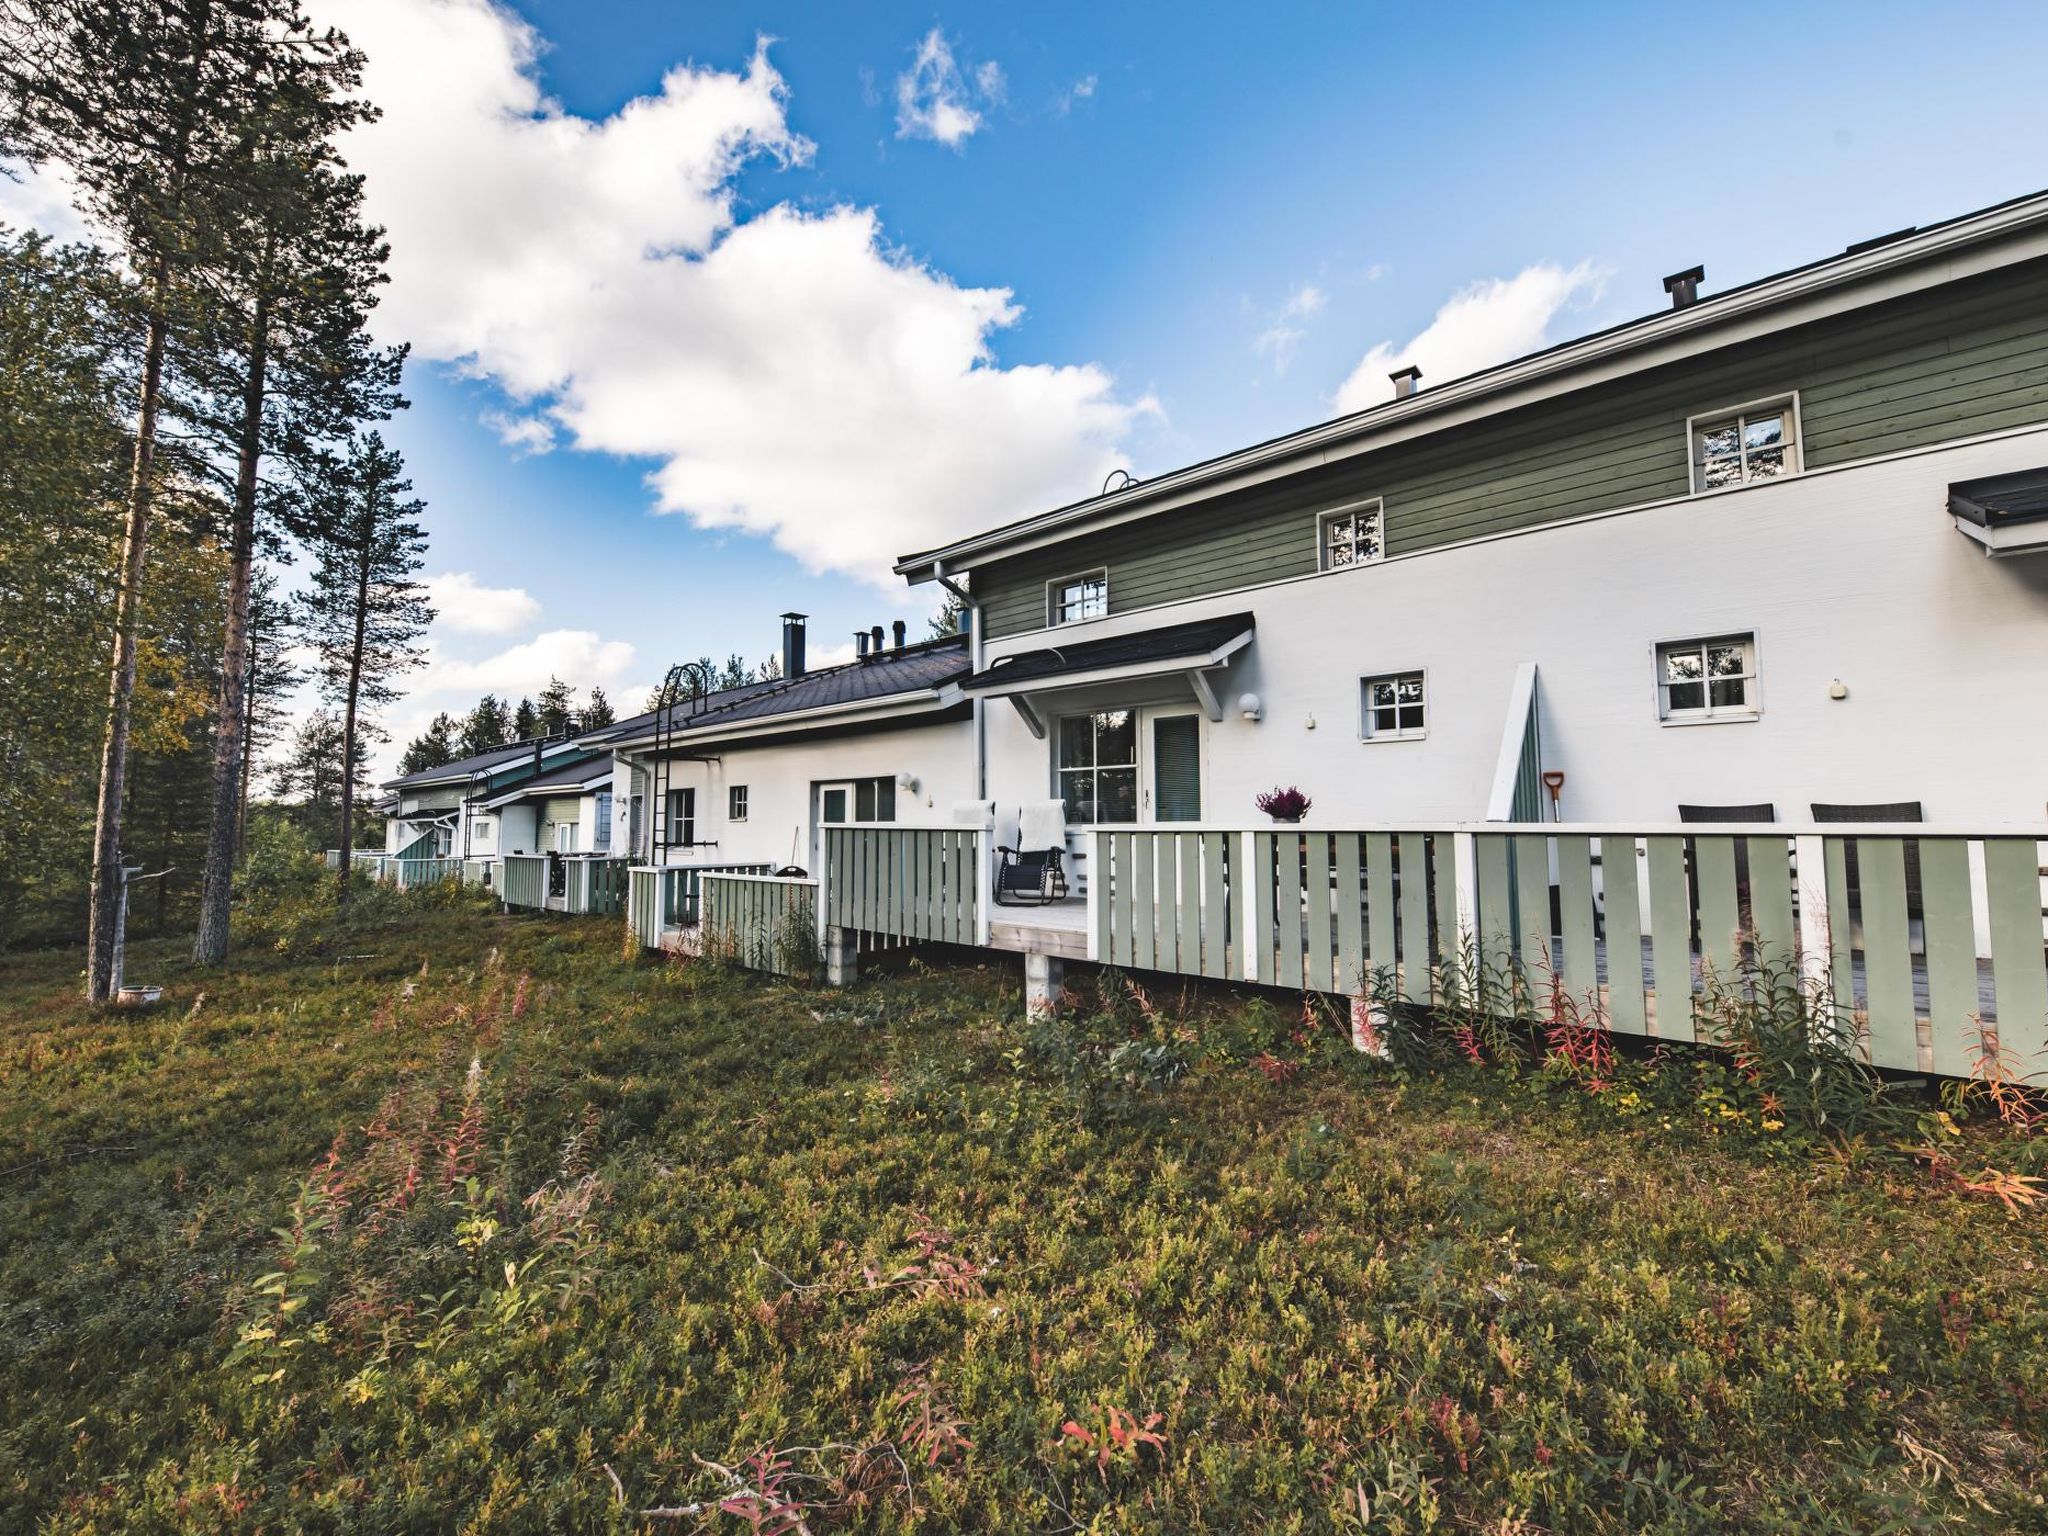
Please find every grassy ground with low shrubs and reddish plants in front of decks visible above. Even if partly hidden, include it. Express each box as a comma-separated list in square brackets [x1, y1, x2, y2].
[0, 909, 2048, 1532]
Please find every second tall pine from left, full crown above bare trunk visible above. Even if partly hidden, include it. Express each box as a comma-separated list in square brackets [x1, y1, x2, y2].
[188, 18, 401, 965]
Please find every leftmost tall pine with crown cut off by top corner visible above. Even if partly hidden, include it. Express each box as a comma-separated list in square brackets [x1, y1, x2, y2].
[0, 0, 323, 1001]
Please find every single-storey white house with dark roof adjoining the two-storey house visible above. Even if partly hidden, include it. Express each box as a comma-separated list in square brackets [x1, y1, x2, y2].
[580, 614, 975, 868]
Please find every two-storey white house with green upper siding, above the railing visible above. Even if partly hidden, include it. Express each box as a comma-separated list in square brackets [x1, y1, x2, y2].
[897, 195, 2048, 843]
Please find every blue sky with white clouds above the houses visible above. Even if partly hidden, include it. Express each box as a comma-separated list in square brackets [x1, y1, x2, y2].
[24, 0, 2048, 770]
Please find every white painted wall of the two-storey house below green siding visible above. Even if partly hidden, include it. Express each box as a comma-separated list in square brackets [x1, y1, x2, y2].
[987, 428, 2048, 825]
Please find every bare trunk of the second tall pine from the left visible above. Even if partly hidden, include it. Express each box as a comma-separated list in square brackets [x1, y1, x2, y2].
[193, 282, 270, 965]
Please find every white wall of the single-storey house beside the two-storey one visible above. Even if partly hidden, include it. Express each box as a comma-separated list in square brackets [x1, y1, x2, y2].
[612, 721, 975, 870]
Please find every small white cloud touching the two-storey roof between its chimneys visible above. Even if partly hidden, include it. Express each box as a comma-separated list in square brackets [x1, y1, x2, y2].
[1331, 262, 1608, 414]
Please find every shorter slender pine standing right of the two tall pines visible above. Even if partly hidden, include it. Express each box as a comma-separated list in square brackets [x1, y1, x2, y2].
[301, 432, 434, 901]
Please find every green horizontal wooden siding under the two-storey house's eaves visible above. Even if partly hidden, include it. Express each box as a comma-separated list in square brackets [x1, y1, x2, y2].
[973, 260, 2048, 637]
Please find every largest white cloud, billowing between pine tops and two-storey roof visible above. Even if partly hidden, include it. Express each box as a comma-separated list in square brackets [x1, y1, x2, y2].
[330, 0, 1151, 586]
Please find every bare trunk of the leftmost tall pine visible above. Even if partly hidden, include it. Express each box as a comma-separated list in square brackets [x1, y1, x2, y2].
[86, 270, 170, 1004]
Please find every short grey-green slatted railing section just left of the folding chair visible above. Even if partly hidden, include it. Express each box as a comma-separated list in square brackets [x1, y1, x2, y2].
[821, 827, 991, 944]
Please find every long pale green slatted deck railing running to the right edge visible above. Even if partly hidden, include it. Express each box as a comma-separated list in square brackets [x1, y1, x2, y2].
[1081, 823, 2048, 1079]
